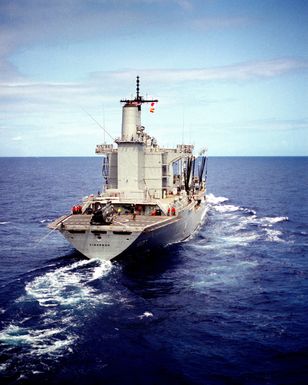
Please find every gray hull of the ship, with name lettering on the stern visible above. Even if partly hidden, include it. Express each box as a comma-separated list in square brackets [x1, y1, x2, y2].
[50, 200, 207, 261]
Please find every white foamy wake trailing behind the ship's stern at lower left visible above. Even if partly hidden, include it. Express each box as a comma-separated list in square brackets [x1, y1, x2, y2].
[0, 260, 112, 364]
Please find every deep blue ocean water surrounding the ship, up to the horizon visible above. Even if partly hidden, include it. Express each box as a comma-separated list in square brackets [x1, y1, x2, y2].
[0, 158, 308, 385]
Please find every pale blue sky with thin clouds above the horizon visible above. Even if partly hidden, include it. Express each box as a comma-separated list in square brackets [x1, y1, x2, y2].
[0, 0, 308, 156]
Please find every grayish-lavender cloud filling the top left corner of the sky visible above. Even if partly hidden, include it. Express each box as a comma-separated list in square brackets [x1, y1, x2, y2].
[0, 0, 248, 80]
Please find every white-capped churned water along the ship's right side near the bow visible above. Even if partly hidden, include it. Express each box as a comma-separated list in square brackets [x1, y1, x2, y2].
[184, 194, 292, 291]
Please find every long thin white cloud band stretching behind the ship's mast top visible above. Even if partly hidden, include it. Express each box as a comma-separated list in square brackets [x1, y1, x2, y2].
[0, 59, 308, 115]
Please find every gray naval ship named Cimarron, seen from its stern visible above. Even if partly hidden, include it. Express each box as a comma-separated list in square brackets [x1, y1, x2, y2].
[49, 76, 207, 261]
